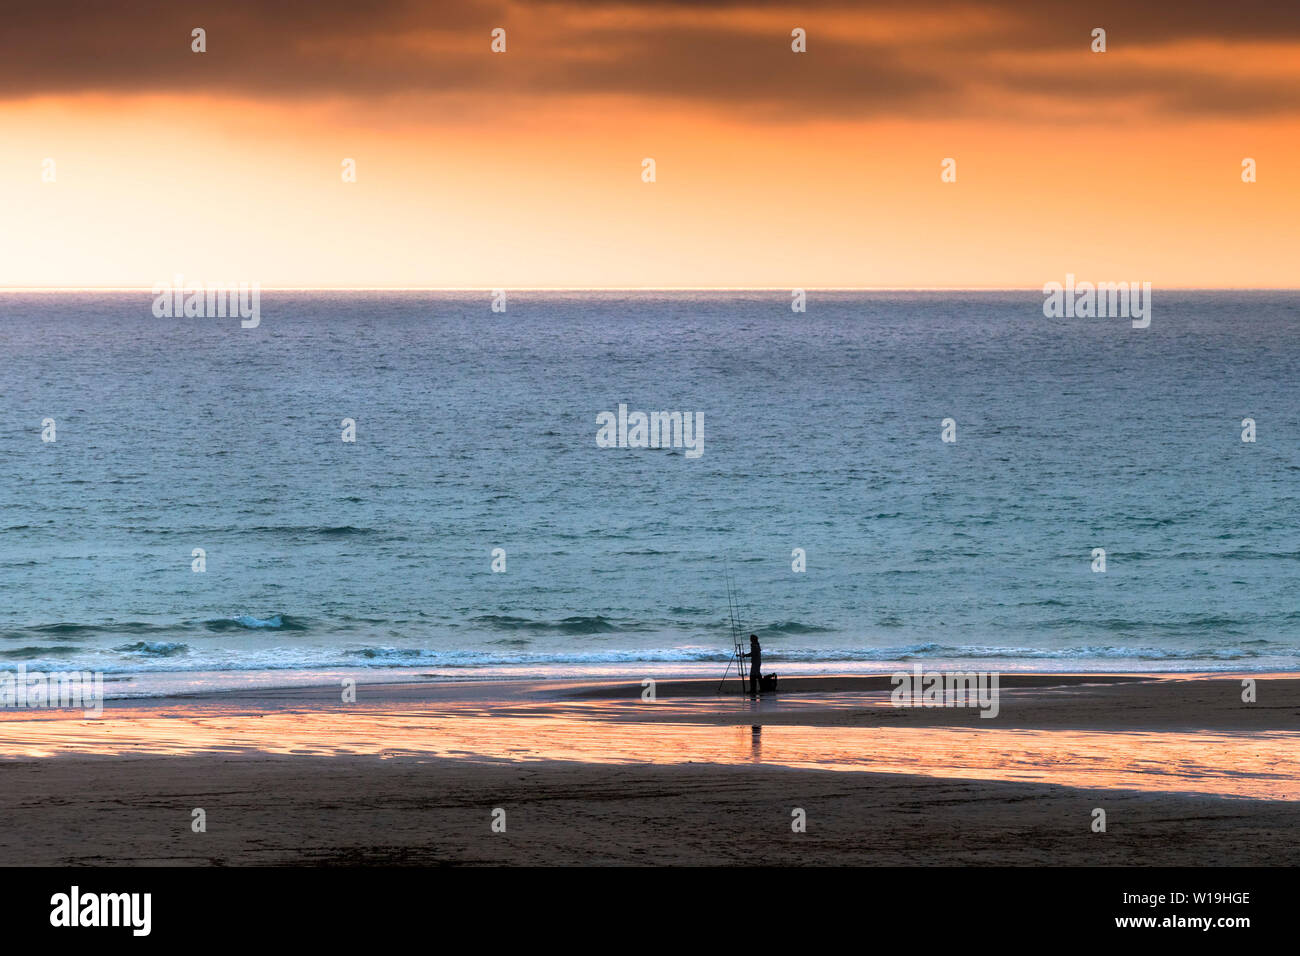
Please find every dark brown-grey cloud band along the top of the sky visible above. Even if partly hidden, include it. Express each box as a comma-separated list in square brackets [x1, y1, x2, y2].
[0, 0, 1300, 117]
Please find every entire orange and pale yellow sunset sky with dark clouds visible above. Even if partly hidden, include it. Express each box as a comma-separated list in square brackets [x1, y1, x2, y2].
[0, 0, 1300, 287]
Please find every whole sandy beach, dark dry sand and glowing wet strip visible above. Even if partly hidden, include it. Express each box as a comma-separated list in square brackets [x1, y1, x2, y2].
[0, 675, 1300, 865]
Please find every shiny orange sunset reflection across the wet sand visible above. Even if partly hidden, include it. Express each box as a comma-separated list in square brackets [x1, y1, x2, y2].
[0, 696, 1300, 800]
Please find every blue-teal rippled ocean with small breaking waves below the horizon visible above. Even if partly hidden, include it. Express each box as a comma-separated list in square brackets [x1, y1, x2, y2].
[0, 289, 1300, 693]
